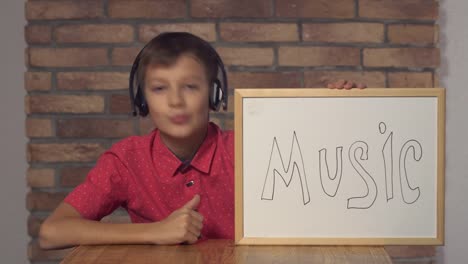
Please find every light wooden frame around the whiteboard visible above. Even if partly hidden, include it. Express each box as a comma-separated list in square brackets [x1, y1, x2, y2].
[234, 88, 445, 245]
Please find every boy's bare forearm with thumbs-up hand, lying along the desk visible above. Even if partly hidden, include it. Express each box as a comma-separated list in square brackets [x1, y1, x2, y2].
[39, 195, 203, 249]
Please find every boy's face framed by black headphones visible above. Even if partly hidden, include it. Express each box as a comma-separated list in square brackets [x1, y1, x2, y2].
[145, 54, 209, 142]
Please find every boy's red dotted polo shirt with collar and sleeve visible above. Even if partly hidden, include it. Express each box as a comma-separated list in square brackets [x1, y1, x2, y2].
[65, 123, 234, 239]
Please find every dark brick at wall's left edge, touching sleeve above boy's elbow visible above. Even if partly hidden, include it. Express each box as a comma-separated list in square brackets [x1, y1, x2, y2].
[26, 191, 67, 211]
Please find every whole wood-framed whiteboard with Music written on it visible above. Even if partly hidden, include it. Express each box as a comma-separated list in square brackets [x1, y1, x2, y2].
[235, 88, 445, 245]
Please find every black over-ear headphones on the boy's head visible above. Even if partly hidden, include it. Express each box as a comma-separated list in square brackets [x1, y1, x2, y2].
[129, 32, 228, 116]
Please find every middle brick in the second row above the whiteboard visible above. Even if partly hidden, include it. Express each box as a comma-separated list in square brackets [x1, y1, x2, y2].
[278, 46, 360, 66]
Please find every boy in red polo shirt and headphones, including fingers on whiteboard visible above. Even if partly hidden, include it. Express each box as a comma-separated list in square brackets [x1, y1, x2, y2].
[39, 32, 364, 248]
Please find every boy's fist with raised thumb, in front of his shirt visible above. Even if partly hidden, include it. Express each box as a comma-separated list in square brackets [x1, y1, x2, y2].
[150, 194, 203, 245]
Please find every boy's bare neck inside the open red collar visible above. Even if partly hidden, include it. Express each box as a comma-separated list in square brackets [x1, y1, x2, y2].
[161, 126, 208, 161]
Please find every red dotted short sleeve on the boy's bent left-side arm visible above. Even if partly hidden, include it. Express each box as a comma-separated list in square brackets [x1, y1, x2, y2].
[64, 152, 127, 220]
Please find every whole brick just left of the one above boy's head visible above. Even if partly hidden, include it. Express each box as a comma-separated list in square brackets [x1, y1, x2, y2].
[54, 24, 134, 43]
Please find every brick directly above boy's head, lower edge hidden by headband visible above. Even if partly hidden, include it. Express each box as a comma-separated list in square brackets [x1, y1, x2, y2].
[139, 23, 216, 43]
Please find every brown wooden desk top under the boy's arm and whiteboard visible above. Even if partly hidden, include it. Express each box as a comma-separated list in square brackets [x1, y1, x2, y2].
[62, 240, 392, 264]
